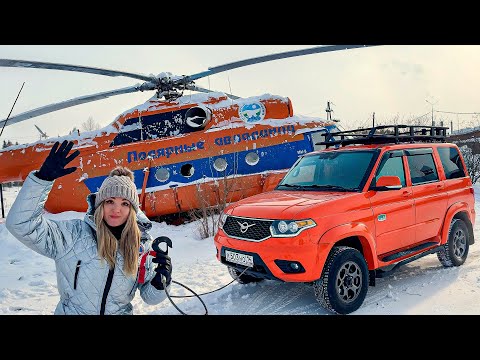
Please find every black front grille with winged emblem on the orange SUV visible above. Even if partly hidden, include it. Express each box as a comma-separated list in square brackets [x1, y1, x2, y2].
[223, 216, 273, 241]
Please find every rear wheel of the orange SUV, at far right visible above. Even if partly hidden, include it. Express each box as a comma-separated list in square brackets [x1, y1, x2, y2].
[437, 219, 469, 267]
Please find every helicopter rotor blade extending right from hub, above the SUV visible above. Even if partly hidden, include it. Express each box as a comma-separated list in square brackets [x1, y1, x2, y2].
[188, 45, 377, 80]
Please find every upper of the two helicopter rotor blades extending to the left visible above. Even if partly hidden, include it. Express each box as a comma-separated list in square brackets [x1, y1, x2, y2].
[0, 59, 155, 81]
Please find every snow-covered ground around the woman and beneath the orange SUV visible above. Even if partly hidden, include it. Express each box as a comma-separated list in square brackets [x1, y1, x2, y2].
[0, 185, 480, 315]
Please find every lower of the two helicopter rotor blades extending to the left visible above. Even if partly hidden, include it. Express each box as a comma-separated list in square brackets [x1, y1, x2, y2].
[0, 83, 155, 126]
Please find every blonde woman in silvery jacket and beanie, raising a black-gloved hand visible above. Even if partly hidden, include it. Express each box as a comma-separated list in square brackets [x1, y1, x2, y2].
[6, 141, 172, 315]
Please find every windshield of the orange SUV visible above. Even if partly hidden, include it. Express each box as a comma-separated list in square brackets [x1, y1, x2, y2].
[276, 150, 378, 191]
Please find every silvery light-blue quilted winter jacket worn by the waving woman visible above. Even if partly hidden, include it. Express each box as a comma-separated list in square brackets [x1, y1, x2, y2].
[6, 171, 168, 315]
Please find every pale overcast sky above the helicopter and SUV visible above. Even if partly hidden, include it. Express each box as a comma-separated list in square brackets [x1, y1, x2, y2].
[0, 45, 480, 143]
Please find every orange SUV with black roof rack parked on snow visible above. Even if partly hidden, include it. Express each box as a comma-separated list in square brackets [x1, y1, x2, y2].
[214, 125, 475, 314]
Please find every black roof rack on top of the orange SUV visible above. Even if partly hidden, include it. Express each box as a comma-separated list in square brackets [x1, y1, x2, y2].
[315, 125, 448, 149]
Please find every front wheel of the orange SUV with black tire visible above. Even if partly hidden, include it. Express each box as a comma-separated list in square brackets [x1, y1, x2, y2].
[313, 246, 369, 314]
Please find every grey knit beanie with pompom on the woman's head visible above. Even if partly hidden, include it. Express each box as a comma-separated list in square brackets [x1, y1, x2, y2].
[95, 167, 140, 212]
